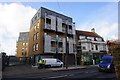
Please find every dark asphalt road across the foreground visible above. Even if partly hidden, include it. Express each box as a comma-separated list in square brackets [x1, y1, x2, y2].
[3, 66, 116, 80]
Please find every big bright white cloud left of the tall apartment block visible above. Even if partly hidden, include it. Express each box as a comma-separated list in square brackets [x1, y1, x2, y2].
[0, 3, 37, 54]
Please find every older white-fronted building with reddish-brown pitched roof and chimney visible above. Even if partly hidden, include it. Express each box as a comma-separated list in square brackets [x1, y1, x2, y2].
[76, 28, 108, 64]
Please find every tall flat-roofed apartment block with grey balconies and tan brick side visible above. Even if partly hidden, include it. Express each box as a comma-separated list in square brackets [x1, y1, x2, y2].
[29, 7, 76, 64]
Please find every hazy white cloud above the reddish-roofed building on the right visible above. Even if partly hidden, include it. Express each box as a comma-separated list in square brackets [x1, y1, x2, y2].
[77, 3, 118, 40]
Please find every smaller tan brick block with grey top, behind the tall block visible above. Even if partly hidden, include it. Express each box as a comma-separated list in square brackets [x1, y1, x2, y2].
[16, 32, 29, 59]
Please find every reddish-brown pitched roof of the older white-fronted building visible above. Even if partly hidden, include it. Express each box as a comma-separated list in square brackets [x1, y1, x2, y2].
[76, 30, 102, 38]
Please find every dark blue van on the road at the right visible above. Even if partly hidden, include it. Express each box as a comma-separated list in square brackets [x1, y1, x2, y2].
[98, 56, 115, 72]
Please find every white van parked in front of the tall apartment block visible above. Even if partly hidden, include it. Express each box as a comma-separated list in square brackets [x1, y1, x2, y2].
[42, 58, 63, 67]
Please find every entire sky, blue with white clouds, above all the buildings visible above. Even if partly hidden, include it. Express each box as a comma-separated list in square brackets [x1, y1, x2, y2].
[0, 2, 118, 54]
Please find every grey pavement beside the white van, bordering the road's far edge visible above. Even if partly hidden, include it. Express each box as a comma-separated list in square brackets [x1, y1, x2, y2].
[2, 65, 96, 76]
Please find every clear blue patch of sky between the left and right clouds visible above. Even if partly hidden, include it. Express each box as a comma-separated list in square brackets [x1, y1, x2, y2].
[22, 2, 117, 27]
